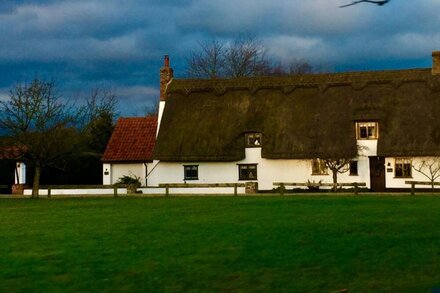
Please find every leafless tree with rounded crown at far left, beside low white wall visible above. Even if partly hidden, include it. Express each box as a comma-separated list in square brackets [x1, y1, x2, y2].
[0, 79, 79, 197]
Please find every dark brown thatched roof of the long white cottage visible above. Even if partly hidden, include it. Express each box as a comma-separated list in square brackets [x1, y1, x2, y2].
[153, 69, 440, 161]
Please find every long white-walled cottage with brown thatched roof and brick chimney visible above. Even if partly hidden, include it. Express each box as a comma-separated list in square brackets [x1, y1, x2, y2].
[104, 52, 440, 192]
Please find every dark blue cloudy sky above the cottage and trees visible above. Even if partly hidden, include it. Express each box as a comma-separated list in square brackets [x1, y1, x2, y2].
[0, 0, 440, 116]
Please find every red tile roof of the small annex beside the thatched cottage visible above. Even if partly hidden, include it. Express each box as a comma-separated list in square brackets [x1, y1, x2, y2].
[102, 117, 157, 162]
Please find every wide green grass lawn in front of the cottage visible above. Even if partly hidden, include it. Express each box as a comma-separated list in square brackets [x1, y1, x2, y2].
[0, 196, 440, 292]
